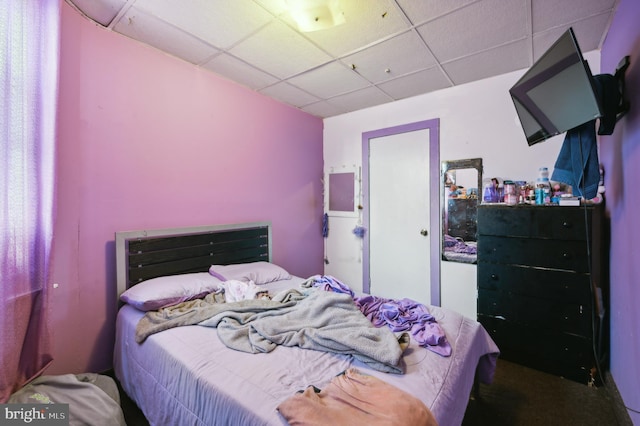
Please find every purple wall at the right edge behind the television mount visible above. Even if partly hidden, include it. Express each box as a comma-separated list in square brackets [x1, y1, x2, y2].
[600, 0, 640, 425]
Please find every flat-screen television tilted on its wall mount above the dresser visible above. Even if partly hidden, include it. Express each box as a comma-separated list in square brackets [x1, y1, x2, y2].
[509, 28, 602, 146]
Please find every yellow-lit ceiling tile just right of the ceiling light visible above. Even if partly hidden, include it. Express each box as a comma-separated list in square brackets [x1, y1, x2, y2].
[305, 0, 410, 57]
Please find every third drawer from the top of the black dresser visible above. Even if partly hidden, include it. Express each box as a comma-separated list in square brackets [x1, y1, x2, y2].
[478, 262, 591, 305]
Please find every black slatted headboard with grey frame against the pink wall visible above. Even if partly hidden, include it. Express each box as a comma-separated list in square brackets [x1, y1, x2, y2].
[116, 222, 271, 296]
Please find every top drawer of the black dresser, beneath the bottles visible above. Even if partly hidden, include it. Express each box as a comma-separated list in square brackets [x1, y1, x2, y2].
[478, 205, 593, 240]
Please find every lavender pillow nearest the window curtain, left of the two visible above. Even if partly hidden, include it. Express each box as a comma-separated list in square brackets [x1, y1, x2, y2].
[120, 272, 220, 312]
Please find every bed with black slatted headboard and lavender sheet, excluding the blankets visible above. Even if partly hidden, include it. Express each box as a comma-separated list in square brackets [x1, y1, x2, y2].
[114, 222, 499, 426]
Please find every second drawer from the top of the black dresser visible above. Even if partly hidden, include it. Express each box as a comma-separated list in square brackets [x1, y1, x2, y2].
[478, 234, 589, 273]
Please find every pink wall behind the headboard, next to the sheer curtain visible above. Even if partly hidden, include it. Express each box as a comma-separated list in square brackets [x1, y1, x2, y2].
[47, 1, 323, 374]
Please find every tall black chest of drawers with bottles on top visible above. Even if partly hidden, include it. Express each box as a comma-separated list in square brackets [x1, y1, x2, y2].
[478, 204, 609, 384]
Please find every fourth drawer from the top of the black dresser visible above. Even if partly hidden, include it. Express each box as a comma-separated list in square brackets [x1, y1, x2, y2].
[478, 289, 591, 337]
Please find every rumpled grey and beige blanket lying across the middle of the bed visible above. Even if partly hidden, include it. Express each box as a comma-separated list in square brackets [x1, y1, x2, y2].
[136, 290, 406, 374]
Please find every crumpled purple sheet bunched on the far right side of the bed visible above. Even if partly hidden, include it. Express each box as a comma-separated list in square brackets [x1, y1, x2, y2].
[307, 275, 451, 356]
